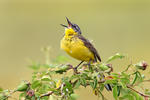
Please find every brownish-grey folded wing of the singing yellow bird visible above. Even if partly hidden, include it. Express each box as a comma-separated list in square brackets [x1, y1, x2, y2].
[77, 34, 101, 62]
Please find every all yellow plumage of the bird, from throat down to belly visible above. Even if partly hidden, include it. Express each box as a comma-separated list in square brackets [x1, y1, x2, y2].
[61, 28, 94, 62]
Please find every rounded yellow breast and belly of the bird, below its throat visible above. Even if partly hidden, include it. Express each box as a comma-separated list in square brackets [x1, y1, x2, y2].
[61, 38, 94, 61]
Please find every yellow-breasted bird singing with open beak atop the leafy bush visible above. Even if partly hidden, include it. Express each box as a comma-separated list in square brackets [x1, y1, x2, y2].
[60, 17, 112, 91]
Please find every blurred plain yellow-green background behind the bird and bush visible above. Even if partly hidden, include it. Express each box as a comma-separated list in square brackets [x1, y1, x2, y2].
[0, 0, 150, 100]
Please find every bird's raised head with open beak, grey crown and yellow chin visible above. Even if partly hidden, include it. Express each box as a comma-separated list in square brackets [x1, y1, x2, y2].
[60, 17, 81, 35]
